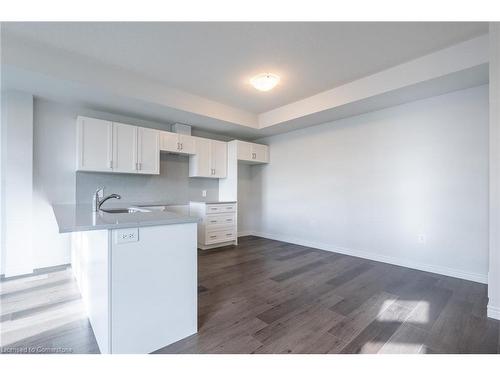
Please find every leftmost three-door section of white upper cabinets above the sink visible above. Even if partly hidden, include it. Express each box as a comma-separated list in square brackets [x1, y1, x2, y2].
[77, 117, 160, 174]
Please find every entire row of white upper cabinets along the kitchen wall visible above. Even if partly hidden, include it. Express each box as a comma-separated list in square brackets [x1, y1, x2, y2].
[76, 116, 238, 178]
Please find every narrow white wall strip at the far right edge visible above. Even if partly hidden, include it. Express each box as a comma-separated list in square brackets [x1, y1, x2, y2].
[488, 22, 500, 319]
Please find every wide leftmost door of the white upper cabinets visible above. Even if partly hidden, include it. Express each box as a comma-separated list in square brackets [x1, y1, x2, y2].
[77, 117, 113, 172]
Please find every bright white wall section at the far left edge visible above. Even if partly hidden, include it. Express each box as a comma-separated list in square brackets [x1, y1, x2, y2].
[1, 91, 34, 277]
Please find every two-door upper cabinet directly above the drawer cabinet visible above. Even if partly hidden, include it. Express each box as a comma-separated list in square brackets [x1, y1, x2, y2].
[189, 137, 227, 178]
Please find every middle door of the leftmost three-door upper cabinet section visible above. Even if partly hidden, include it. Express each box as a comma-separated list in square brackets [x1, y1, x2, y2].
[112, 122, 137, 173]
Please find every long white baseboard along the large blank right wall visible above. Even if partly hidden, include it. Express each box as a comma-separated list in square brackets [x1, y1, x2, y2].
[247, 231, 488, 284]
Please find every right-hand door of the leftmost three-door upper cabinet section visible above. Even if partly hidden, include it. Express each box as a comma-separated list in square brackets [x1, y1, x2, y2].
[137, 128, 160, 174]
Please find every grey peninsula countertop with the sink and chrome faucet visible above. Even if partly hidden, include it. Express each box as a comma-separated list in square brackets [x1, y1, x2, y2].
[52, 204, 199, 233]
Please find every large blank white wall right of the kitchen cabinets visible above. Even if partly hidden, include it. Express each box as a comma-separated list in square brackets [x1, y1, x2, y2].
[248, 86, 488, 282]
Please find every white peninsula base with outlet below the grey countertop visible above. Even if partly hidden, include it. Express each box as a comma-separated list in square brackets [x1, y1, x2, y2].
[72, 223, 198, 354]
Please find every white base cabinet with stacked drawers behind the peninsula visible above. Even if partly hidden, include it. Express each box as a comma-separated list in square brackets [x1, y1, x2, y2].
[189, 202, 238, 249]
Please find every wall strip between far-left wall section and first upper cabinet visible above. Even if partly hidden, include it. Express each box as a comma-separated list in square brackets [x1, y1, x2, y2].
[33, 99, 76, 268]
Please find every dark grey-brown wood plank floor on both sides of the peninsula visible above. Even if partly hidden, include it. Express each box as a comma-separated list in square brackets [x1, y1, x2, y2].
[1, 237, 500, 353]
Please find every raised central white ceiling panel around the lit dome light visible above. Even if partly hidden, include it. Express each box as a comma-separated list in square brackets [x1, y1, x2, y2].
[2, 22, 488, 113]
